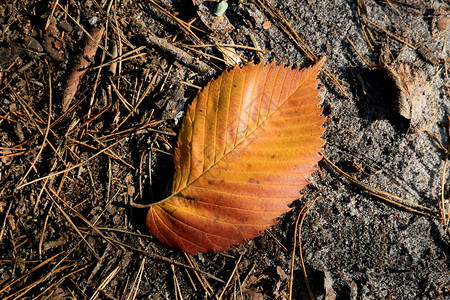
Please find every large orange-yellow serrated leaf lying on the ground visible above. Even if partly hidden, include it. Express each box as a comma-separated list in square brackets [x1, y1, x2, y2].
[146, 59, 325, 254]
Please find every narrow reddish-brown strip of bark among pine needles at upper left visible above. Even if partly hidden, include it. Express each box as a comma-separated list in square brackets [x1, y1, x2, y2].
[63, 26, 105, 112]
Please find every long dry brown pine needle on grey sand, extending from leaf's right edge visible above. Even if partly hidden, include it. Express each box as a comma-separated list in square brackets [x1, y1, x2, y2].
[322, 154, 437, 218]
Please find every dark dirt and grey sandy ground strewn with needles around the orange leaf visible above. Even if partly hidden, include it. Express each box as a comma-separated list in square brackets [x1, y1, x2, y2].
[0, 0, 450, 299]
